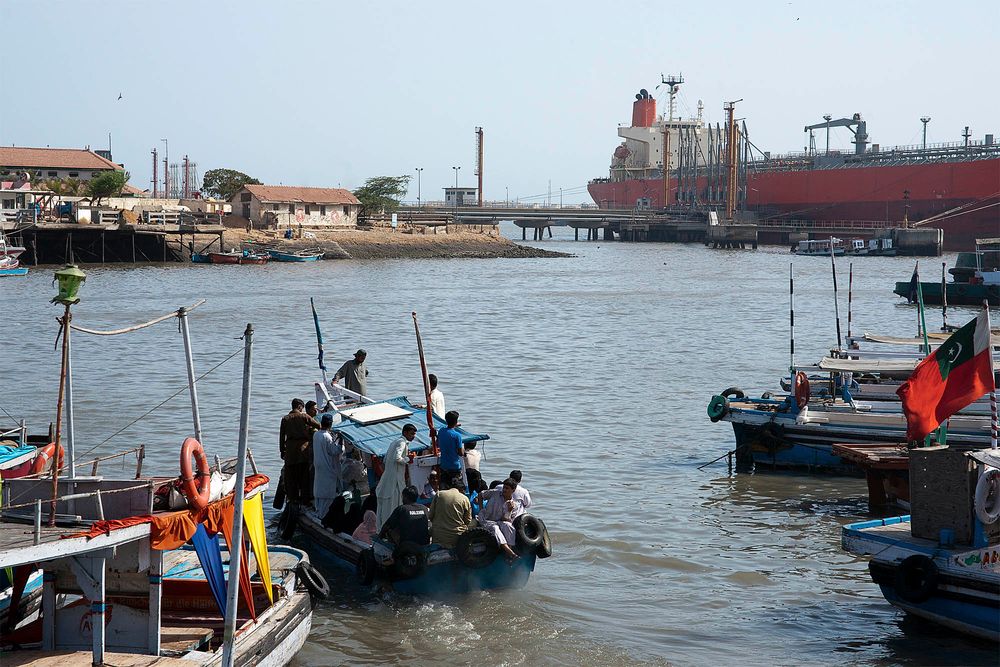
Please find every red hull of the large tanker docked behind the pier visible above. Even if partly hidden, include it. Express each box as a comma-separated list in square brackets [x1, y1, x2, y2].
[588, 159, 1000, 250]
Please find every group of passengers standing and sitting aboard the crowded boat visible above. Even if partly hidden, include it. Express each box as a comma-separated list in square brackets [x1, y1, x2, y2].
[278, 349, 531, 559]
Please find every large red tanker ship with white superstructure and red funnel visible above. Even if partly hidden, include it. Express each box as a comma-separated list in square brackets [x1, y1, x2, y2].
[588, 84, 1000, 250]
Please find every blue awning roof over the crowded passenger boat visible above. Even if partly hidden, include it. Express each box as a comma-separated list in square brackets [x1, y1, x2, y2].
[333, 396, 490, 457]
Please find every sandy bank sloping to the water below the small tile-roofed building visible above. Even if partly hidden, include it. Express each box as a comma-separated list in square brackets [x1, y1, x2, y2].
[216, 228, 570, 259]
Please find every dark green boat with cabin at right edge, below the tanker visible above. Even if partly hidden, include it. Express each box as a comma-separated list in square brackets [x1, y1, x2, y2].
[893, 238, 1000, 306]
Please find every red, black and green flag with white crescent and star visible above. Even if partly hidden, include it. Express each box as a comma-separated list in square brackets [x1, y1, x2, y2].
[896, 310, 993, 440]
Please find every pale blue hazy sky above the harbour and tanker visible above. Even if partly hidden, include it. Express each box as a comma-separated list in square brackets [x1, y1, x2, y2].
[0, 0, 1000, 204]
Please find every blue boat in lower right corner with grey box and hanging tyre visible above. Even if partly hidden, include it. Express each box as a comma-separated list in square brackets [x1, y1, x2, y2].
[841, 447, 1000, 642]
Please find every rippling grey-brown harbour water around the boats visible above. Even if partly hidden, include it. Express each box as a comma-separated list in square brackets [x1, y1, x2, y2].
[0, 229, 996, 665]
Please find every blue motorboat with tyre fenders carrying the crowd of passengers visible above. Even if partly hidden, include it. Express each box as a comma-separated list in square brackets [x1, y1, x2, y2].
[279, 390, 551, 596]
